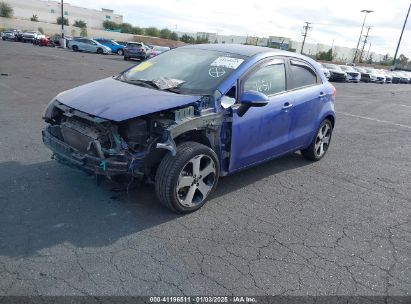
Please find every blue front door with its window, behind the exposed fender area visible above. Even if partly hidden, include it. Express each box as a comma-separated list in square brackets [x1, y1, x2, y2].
[229, 58, 293, 172]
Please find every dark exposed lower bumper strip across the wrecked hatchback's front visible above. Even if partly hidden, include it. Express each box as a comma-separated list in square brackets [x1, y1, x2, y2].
[42, 128, 131, 176]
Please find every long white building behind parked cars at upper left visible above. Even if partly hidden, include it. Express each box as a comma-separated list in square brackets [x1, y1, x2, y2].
[6, 0, 123, 29]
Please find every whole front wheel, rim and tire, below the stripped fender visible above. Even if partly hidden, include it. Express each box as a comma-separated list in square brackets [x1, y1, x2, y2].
[155, 142, 220, 213]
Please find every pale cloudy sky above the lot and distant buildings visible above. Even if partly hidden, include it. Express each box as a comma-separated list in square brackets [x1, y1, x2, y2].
[66, 0, 411, 58]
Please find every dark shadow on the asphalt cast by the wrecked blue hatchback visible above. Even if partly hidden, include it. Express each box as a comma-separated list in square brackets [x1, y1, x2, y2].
[0, 154, 310, 257]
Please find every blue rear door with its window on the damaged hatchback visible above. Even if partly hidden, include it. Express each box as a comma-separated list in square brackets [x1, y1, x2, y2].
[288, 58, 327, 150]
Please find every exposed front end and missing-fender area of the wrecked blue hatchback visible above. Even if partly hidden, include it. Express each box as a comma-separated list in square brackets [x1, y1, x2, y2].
[43, 97, 229, 180]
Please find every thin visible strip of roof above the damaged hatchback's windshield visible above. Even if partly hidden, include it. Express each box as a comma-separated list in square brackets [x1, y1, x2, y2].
[184, 43, 292, 57]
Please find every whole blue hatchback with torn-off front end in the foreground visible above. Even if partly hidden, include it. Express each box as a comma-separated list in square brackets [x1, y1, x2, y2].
[42, 44, 336, 213]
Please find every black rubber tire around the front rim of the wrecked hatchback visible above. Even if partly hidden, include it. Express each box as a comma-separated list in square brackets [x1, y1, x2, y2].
[155, 142, 220, 213]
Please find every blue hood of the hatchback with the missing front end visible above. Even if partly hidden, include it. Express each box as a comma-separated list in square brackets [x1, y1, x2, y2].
[56, 78, 199, 121]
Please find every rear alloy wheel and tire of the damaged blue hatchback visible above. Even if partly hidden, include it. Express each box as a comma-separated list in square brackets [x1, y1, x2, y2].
[301, 119, 333, 161]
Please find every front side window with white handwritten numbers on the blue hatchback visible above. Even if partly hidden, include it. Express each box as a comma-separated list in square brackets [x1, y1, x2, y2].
[244, 63, 286, 95]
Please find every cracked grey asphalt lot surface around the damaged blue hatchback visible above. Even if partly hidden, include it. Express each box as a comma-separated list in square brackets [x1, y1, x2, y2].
[0, 41, 411, 296]
